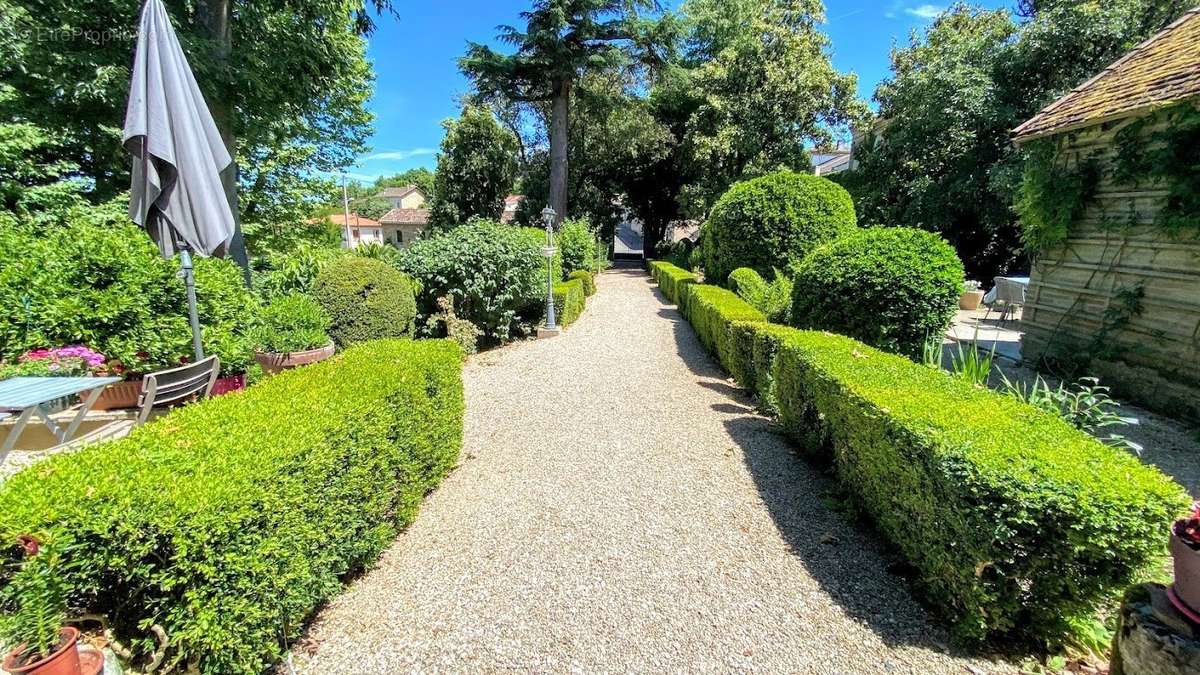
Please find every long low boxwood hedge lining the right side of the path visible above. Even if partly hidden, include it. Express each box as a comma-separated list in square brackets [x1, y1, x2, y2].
[652, 271, 1190, 641]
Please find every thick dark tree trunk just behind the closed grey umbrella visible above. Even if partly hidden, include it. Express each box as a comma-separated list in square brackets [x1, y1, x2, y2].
[197, 0, 251, 287]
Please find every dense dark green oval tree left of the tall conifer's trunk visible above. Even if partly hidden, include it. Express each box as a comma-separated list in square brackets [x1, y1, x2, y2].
[430, 106, 517, 227]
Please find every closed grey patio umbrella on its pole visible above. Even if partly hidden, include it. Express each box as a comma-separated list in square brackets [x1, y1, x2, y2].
[122, 0, 234, 360]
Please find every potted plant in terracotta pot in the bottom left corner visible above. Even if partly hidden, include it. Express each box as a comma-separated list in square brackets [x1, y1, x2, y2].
[0, 534, 104, 675]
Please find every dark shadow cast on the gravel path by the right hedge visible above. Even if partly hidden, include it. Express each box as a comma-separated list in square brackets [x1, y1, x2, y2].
[652, 269, 967, 656]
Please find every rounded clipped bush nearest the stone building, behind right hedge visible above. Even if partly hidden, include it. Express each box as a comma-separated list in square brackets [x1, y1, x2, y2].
[792, 227, 962, 358]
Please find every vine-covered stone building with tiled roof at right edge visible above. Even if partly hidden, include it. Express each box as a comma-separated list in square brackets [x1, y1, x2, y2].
[1014, 10, 1200, 420]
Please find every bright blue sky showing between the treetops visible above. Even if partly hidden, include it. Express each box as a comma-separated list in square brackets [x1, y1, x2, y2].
[348, 0, 1010, 180]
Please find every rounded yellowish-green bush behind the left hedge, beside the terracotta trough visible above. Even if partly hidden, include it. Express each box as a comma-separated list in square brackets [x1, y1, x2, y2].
[312, 256, 416, 348]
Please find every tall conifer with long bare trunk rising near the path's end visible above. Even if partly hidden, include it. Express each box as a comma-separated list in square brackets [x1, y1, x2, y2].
[460, 0, 671, 219]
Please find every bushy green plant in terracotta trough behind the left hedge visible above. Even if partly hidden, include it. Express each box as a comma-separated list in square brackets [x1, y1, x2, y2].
[252, 293, 334, 375]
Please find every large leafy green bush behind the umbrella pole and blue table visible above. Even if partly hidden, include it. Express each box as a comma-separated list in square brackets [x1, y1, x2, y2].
[0, 220, 258, 374]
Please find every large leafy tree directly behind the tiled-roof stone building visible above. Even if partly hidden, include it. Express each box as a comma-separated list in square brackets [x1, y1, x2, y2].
[842, 0, 1187, 280]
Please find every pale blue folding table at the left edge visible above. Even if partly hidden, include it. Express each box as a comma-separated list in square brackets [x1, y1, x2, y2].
[0, 377, 121, 461]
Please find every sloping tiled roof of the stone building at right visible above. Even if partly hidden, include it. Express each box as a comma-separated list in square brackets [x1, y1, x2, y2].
[1013, 7, 1200, 142]
